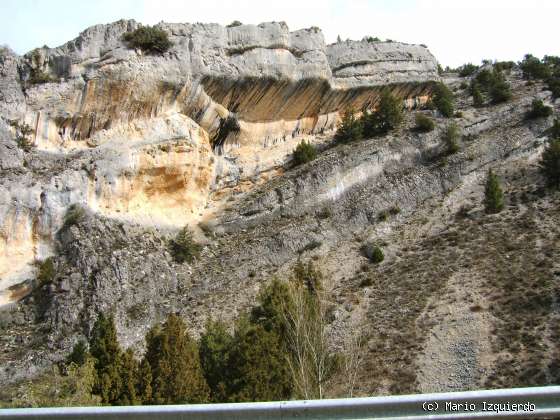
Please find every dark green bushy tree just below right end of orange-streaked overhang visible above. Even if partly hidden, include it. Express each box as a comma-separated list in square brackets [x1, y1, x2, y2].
[362, 90, 403, 137]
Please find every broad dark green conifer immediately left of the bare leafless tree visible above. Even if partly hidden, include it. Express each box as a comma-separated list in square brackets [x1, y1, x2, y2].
[229, 317, 293, 402]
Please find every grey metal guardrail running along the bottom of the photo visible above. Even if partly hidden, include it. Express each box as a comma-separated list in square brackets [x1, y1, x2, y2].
[0, 386, 560, 420]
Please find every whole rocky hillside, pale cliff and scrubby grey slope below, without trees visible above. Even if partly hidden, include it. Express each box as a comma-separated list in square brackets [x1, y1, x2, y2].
[0, 21, 560, 404]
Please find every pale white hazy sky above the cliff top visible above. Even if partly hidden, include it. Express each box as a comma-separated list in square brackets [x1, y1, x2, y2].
[0, 0, 560, 67]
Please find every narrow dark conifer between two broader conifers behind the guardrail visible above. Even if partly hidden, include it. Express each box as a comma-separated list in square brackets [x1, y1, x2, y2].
[199, 320, 233, 403]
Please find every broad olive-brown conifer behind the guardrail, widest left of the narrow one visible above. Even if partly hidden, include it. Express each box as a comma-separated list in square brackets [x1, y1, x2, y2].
[145, 314, 209, 404]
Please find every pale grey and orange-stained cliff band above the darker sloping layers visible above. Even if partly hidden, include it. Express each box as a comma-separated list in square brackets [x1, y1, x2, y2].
[0, 20, 438, 304]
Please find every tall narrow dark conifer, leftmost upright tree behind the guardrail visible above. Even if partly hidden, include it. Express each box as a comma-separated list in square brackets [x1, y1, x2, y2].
[89, 313, 122, 404]
